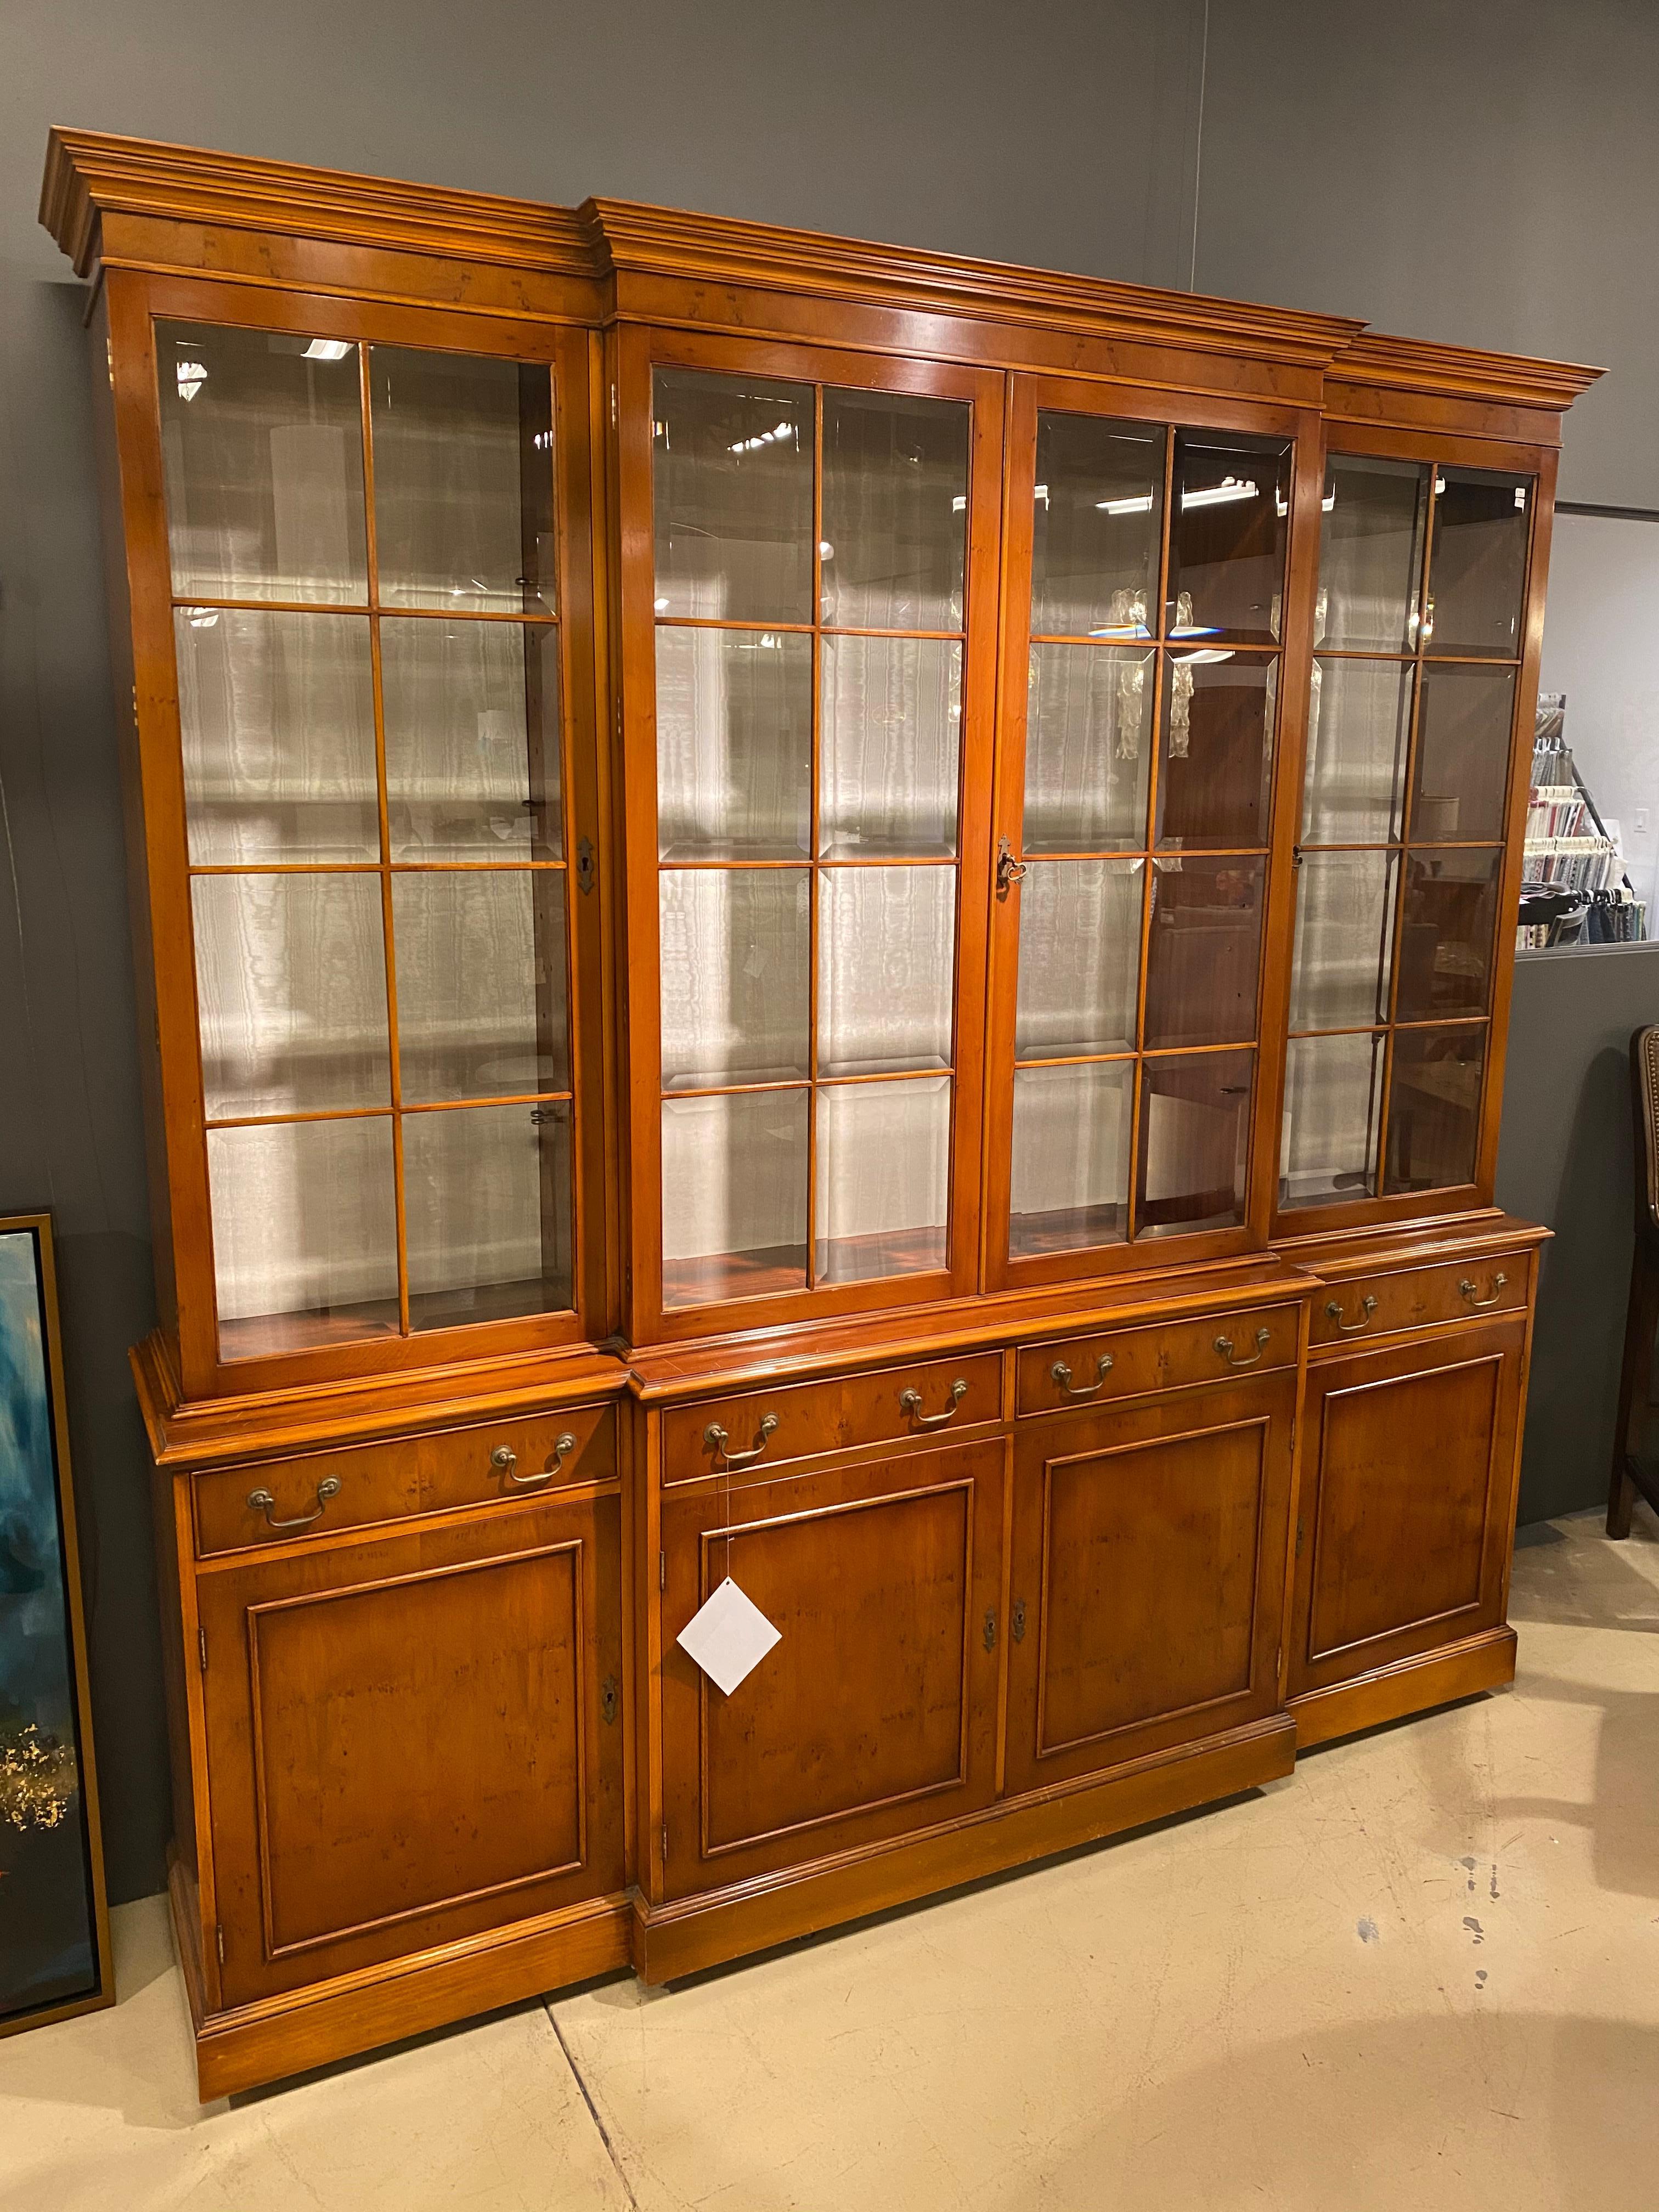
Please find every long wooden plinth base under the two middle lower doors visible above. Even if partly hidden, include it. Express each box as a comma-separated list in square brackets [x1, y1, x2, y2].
[633, 1712, 1296, 1982]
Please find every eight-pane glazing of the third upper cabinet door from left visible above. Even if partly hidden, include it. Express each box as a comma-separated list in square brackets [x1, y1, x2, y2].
[1002, 407, 1292, 1263]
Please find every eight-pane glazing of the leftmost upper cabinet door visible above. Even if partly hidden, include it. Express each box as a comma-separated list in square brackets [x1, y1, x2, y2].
[157, 323, 575, 1361]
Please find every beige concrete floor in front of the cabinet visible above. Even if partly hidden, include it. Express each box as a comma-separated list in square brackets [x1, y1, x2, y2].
[0, 1511, 1659, 2212]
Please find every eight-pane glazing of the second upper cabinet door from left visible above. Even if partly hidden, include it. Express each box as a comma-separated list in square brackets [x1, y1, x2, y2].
[650, 365, 986, 1310]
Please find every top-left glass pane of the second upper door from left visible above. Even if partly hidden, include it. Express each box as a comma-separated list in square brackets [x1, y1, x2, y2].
[650, 369, 814, 622]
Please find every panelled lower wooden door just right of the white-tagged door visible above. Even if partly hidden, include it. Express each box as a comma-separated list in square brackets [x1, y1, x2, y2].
[1007, 1374, 1296, 1792]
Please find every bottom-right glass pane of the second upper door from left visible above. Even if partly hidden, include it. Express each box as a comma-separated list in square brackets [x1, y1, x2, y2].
[814, 1075, 951, 1283]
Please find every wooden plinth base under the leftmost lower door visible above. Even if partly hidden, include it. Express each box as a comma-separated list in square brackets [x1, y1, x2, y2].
[168, 1869, 628, 2103]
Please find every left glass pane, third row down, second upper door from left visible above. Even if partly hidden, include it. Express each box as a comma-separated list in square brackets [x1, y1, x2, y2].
[659, 867, 812, 1091]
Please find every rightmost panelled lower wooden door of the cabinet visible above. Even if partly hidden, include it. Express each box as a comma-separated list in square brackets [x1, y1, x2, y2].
[1290, 1323, 1526, 1697]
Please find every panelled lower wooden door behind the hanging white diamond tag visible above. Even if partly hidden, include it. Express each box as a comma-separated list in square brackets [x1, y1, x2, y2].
[657, 1442, 1007, 1898]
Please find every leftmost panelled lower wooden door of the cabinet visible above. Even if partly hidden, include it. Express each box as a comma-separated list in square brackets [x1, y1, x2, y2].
[199, 1493, 624, 2004]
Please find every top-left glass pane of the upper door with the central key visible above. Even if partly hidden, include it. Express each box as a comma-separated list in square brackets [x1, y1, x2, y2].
[1031, 411, 1168, 639]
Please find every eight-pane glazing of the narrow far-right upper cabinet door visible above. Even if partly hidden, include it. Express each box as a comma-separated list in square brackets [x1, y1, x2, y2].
[1278, 454, 1535, 1207]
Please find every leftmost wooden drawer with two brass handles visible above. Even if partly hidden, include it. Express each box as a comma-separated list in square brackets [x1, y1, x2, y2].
[190, 1404, 617, 1560]
